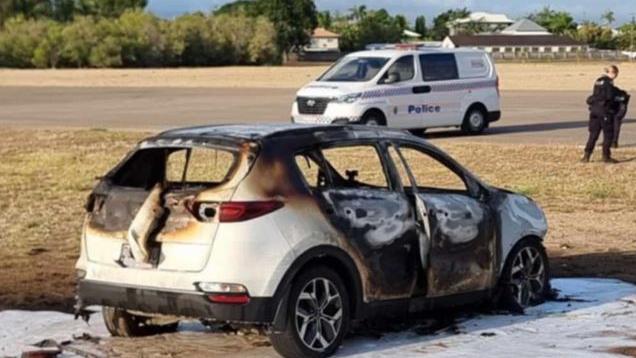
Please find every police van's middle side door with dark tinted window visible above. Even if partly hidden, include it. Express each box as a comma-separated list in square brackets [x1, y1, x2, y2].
[418, 53, 463, 127]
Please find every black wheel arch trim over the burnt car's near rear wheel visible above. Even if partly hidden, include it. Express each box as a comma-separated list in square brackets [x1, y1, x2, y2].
[272, 245, 364, 331]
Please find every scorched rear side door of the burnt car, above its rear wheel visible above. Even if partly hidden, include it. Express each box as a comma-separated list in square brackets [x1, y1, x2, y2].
[296, 141, 419, 301]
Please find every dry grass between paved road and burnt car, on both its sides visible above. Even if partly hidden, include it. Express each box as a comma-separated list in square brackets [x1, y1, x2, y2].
[0, 129, 636, 309]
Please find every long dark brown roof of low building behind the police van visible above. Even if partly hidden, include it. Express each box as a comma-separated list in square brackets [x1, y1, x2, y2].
[449, 35, 583, 47]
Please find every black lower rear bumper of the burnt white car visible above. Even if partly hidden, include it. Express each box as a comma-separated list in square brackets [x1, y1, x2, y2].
[77, 280, 276, 324]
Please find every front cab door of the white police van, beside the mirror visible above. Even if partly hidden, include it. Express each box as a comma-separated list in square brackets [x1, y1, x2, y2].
[378, 55, 418, 128]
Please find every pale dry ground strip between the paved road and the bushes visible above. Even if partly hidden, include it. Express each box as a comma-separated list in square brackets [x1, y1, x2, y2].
[0, 62, 636, 91]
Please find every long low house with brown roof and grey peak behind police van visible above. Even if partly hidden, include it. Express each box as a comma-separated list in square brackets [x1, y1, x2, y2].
[442, 19, 588, 58]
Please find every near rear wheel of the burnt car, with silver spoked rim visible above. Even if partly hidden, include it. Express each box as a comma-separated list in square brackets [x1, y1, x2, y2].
[270, 266, 350, 358]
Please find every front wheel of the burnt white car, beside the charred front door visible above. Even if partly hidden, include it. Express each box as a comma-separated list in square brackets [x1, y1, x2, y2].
[499, 238, 551, 313]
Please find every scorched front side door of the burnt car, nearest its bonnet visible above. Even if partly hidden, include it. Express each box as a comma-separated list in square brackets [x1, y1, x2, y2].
[392, 143, 497, 297]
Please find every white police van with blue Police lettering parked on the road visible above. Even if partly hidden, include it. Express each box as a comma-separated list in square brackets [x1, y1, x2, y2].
[291, 48, 501, 134]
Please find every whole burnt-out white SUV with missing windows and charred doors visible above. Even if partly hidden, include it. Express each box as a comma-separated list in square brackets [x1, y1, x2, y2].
[76, 125, 549, 357]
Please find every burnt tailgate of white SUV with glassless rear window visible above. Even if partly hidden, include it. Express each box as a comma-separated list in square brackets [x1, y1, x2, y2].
[84, 140, 249, 271]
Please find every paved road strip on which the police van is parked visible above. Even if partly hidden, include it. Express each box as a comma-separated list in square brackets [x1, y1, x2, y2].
[0, 87, 636, 146]
